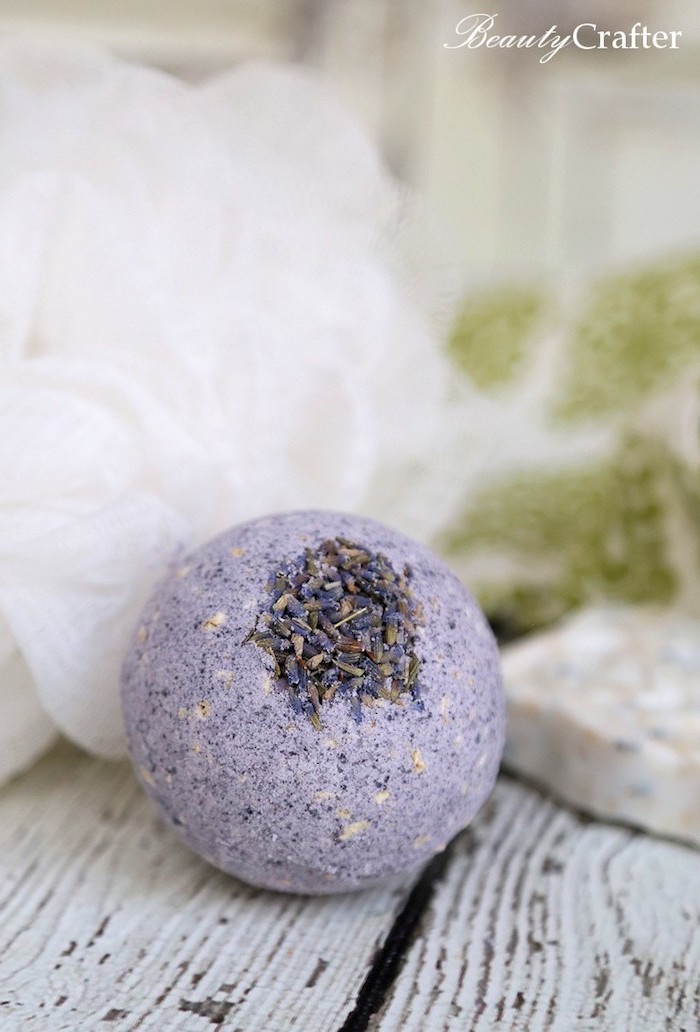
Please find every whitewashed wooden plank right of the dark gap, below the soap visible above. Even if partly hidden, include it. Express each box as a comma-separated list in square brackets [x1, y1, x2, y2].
[375, 778, 700, 1032]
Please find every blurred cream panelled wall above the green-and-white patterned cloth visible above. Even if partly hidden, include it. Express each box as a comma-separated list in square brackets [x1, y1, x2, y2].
[0, 0, 700, 279]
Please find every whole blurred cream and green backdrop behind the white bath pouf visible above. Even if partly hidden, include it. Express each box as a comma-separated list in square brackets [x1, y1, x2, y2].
[0, 0, 700, 652]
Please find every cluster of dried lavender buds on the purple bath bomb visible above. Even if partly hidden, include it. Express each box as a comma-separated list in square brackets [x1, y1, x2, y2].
[243, 538, 421, 731]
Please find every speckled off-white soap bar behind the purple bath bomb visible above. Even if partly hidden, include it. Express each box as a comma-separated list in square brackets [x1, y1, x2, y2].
[503, 607, 700, 845]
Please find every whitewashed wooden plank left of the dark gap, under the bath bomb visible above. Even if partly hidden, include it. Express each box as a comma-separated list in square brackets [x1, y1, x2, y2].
[0, 746, 406, 1032]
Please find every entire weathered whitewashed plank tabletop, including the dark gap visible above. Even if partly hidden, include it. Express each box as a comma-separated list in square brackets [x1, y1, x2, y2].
[0, 745, 700, 1032]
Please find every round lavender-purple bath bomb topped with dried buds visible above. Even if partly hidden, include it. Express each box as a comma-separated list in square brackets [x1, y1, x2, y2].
[122, 512, 505, 894]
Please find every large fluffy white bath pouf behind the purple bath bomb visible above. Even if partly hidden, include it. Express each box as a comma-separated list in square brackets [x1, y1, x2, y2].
[0, 41, 470, 777]
